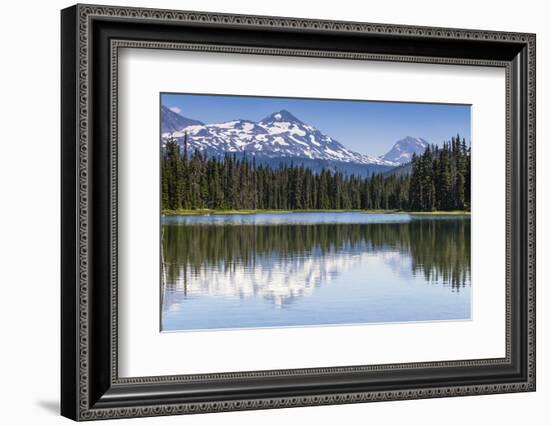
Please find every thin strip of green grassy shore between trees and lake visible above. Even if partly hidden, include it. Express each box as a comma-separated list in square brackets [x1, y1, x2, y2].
[161, 209, 471, 216]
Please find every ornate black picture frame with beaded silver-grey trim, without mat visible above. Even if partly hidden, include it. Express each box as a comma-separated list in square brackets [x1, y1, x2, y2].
[61, 5, 535, 420]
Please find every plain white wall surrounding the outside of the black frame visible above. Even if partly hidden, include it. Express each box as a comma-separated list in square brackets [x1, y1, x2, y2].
[0, 0, 550, 426]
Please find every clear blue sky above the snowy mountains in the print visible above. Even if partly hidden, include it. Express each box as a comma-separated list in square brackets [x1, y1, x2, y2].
[161, 93, 470, 156]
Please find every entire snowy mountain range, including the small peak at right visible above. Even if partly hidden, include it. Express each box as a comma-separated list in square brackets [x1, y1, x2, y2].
[161, 106, 434, 176]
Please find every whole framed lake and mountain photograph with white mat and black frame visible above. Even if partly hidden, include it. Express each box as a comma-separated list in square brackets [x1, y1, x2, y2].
[61, 5, 535, 420]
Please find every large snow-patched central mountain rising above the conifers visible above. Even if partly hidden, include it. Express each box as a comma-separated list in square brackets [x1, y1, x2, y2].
[162, 110, 397, 168]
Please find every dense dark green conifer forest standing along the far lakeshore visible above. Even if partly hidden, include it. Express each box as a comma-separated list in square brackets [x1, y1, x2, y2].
[161, 136, 470, 211]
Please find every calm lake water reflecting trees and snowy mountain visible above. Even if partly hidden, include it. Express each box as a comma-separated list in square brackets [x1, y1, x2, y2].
[161, 212, 471, 331]
